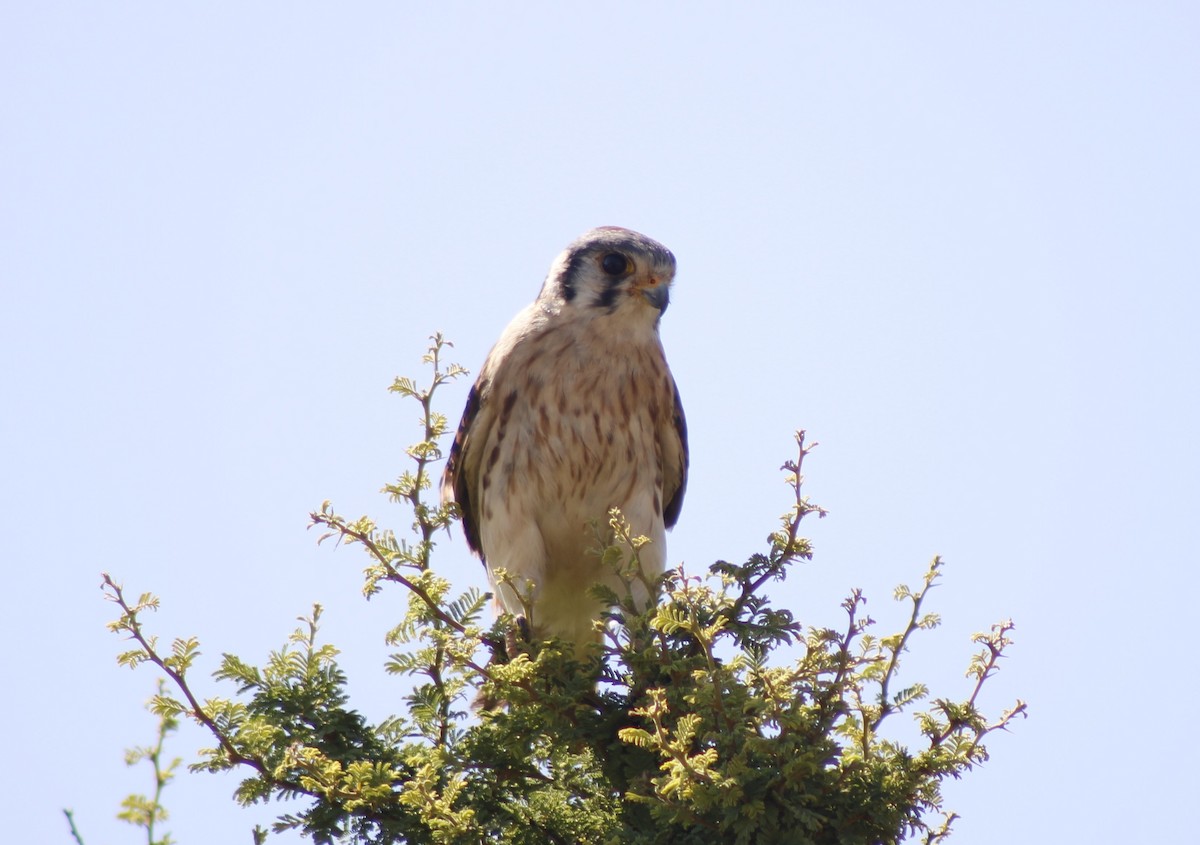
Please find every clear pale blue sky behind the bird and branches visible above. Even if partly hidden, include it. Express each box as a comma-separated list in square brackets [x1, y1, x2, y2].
[0, 1, 1200, 845]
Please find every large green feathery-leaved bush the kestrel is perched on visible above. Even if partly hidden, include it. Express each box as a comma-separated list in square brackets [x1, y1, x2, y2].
[103, 336, 1025, 845]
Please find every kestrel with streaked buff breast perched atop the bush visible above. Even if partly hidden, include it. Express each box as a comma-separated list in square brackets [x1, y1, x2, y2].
[442, 226, 688, 643]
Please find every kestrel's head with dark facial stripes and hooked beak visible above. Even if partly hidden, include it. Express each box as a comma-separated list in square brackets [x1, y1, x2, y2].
[538, 226, 674, 323]
